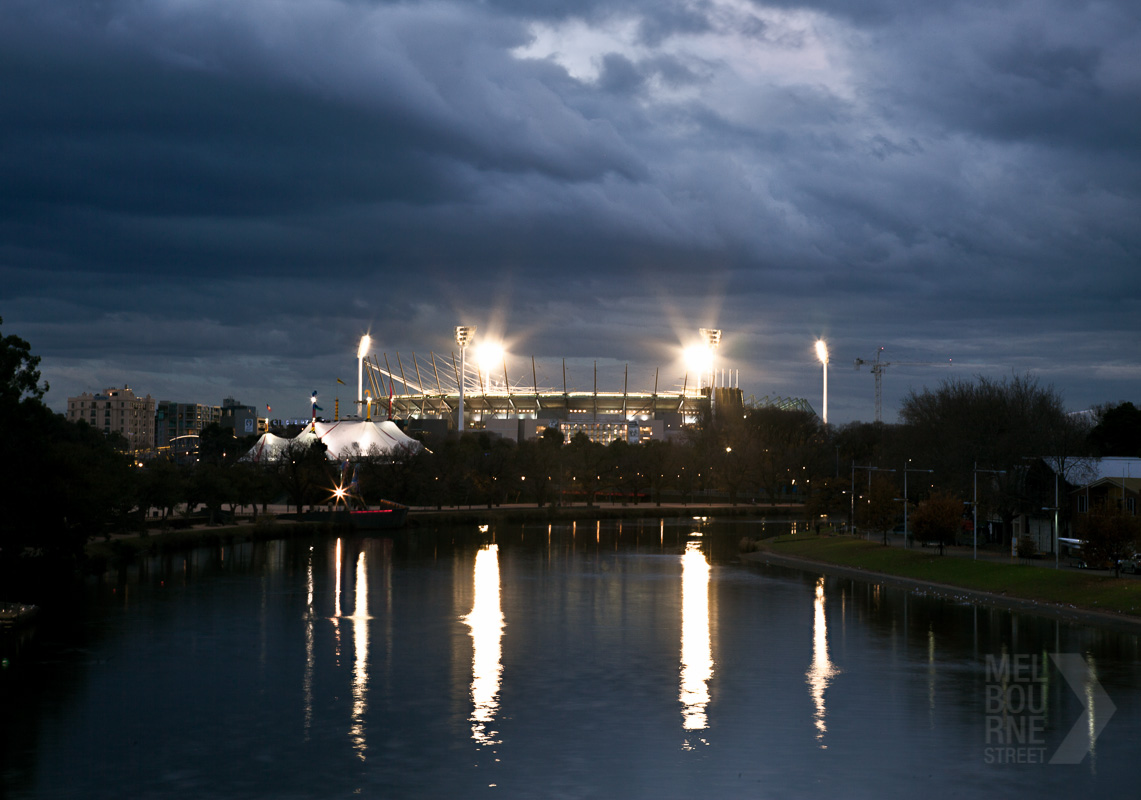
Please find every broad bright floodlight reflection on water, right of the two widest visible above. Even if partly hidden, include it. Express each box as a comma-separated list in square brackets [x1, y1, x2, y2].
[679, 542, 713, 750]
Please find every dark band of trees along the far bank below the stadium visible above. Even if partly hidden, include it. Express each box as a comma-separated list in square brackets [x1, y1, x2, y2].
[0, 321, 1141, 598]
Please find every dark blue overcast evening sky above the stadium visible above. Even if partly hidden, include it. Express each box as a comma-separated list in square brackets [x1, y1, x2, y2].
[0, 0, 1141, 422]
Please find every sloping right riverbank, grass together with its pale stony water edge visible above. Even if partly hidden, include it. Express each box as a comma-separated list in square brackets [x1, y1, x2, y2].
[742, 535, 1141, 633]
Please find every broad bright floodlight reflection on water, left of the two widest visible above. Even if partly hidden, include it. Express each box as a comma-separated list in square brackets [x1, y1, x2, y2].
[463, 544, 503, 744]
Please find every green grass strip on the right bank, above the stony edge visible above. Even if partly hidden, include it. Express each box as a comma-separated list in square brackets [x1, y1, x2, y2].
[763, 535, 1141, 616]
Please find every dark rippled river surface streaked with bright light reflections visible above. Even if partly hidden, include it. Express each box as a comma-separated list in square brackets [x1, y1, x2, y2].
[2, 519, 1141, 798]
